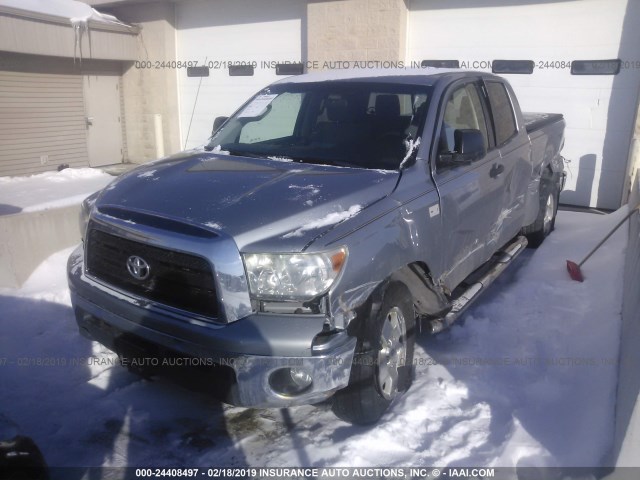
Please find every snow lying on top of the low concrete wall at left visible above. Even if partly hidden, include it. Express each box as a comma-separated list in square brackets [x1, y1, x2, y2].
[0, 168, 114, 215]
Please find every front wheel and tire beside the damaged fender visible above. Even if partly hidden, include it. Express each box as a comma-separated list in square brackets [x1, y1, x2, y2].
[333, 283, 416, 425]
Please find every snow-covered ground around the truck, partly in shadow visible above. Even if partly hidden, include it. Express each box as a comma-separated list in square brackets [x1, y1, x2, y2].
[0, 212, 626, 472]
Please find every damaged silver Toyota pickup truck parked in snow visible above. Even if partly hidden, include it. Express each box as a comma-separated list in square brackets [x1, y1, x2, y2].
[68, 69, 564, 423]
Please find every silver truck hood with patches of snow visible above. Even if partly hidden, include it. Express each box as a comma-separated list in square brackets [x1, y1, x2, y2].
[96, 151, 399, 252]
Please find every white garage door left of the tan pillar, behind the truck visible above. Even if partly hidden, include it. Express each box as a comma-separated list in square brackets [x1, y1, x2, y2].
[176, 0, 306, 148]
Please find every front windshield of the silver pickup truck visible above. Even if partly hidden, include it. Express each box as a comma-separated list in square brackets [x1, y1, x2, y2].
[206, 82, 430, 170]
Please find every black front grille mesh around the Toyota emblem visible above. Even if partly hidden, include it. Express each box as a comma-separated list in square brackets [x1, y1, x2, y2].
[86, 228, 218, 318]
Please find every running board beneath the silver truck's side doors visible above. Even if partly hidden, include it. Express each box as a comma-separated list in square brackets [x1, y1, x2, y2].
[429, 236, 527, 334]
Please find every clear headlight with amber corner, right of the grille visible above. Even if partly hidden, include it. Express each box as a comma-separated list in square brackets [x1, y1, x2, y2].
[244, 248, 347, 300]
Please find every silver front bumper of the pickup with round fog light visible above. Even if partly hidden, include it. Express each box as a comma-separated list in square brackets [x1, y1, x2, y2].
[67, 247, 356, 407]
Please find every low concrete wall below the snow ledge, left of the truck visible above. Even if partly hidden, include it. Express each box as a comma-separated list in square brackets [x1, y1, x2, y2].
[0, 205, 81, 288]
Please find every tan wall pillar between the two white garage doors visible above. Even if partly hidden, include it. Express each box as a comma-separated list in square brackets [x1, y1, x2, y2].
[307, 0, 407, 67]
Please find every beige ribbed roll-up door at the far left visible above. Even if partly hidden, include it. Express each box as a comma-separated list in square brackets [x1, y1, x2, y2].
[0, 56, 88, 176]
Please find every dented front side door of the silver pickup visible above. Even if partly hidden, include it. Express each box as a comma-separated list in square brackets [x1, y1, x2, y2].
[432, 80, 503, 290]
